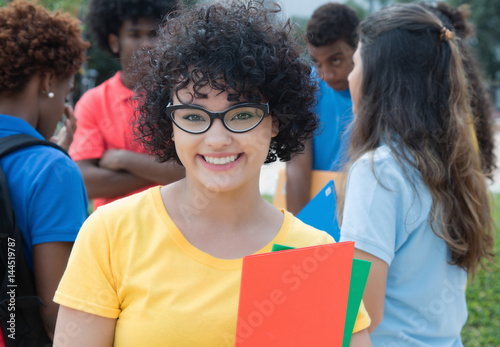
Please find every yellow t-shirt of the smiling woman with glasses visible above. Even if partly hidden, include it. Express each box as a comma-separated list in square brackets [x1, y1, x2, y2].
[54, 187, 370, 347]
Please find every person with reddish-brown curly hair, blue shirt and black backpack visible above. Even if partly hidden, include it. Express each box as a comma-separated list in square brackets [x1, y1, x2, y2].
[0, 0, 88, 346]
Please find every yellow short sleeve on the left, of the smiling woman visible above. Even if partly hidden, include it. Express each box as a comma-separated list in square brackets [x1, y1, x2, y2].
[54, 211, 120, 318]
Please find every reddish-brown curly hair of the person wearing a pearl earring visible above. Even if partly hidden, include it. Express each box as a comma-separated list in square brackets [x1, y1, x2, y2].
[0, 0, 88, 97]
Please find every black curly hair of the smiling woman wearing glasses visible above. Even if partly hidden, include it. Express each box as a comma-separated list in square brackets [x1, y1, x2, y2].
[137, 1, 317, 163]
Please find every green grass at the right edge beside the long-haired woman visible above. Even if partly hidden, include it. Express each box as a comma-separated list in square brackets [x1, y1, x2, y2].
[462, 194, 500, 347]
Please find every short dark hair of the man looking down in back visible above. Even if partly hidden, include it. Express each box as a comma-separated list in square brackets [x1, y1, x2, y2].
[306, 3, 359, 49]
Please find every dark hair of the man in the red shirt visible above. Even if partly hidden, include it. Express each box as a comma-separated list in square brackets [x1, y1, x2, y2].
[85, 0, 178, 57]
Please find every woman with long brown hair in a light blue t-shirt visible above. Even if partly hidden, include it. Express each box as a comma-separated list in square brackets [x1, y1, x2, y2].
[341, 4, 493, 346]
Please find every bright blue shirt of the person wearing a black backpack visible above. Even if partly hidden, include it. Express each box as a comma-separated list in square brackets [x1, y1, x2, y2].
[0, 115, 88, 268]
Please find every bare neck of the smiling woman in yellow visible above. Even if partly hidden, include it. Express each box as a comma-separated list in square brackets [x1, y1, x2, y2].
[164, 179, 284, 259]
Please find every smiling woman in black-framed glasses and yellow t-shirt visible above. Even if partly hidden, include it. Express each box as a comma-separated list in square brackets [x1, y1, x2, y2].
[55, 1, 371, 347]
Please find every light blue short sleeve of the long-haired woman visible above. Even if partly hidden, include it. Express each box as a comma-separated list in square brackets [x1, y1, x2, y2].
[340, 153, 406, 265]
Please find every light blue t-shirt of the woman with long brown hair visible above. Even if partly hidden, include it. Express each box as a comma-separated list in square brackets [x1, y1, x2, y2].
[340, 145, 467, 347]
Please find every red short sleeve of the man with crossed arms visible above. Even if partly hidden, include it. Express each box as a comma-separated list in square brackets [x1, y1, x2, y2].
[69, 90, 106, 161]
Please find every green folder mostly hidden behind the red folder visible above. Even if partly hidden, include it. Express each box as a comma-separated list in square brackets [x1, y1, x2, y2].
[272, 244, 371, 347]
